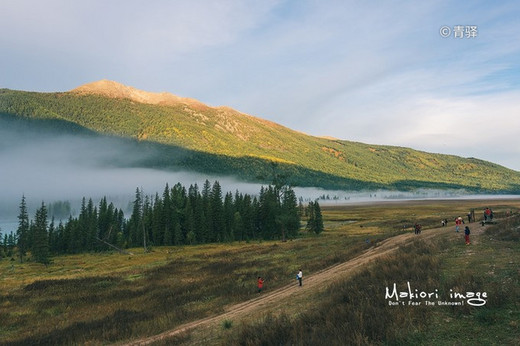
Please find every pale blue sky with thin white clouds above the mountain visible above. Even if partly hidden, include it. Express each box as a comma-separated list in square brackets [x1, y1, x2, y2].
[0, 0, 520, 171]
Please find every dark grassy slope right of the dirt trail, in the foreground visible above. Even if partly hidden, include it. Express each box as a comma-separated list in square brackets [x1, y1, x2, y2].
[222, 201, 520, 345]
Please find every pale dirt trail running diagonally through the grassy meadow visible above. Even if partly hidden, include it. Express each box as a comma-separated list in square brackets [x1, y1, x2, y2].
[122, 223, 486, 345]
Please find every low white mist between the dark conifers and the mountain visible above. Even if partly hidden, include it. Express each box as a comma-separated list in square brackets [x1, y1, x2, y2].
[0, 114, 500, 233]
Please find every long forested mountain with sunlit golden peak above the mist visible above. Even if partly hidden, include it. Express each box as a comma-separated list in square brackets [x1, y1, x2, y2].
[0, 80, 520, 192]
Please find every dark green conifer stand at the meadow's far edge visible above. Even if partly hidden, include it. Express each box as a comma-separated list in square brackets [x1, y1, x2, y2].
[8, 180, 323, 263]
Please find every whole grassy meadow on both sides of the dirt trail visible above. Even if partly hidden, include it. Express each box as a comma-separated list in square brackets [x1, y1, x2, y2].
[0, 200, 520, 345]
